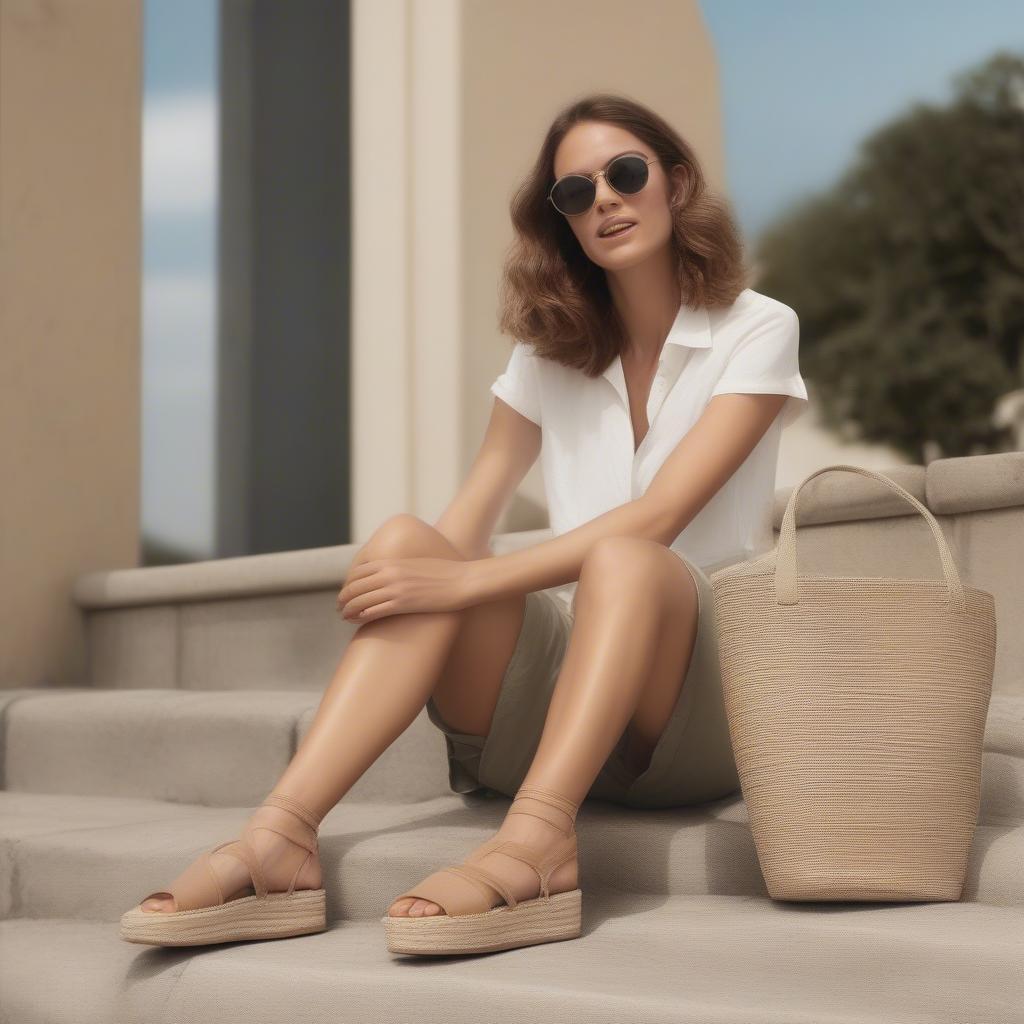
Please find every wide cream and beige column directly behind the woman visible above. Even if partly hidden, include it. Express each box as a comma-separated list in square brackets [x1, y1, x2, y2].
[352, 0, 724, 541]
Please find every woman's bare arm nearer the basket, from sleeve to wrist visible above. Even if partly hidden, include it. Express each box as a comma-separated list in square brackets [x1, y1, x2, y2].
[470, 394, 786, 603]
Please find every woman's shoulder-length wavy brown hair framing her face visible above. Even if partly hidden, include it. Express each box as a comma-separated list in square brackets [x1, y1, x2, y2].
[499, 93, 750, 377]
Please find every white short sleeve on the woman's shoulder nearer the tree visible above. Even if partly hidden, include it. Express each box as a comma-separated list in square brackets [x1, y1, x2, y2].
[711, 306, 808, 426]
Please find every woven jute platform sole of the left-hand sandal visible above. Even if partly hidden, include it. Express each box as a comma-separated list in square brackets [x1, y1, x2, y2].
[121, 889, 327, 946]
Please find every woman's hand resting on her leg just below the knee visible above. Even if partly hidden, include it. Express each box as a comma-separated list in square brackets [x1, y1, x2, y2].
[337, 558, 473, 624]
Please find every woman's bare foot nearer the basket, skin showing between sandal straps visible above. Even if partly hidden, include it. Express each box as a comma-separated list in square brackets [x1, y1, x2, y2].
[388, 814, 579, 918]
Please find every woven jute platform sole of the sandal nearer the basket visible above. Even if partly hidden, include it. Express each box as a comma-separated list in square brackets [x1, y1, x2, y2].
[381, 889, 583, 956]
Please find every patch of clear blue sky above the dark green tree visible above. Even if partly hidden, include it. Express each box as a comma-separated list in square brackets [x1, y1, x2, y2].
[699, 0, 1024, 239]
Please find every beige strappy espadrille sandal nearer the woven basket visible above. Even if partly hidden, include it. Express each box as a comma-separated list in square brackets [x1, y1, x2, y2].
[381, 785, 583, 955]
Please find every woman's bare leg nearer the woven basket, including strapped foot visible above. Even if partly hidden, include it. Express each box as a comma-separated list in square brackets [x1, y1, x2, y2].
[389, 537, 697, 916]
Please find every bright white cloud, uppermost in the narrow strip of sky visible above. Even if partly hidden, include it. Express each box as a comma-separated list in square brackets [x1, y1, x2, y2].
[142, 92, 220, 217]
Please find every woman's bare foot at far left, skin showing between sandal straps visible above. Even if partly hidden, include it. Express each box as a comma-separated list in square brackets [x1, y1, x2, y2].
[141, 805, 324, 913]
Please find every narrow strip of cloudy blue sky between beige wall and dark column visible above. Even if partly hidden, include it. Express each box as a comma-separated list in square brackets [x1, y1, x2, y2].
[141, 0, 218, 558]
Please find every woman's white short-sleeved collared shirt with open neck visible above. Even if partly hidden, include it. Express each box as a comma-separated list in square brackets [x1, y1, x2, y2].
[490, 288, 808, 604]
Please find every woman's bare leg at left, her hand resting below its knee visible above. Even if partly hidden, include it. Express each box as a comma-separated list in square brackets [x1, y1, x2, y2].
[142, 515, 521, 911]
